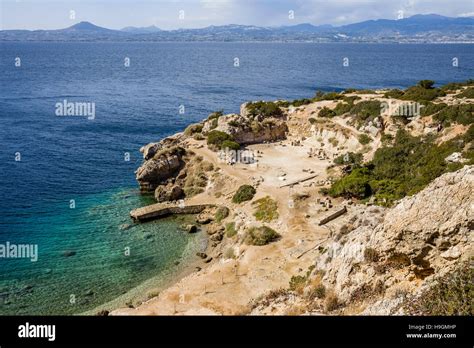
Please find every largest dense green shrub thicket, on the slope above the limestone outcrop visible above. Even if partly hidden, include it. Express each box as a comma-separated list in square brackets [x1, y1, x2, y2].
[328, 130, 468, 206]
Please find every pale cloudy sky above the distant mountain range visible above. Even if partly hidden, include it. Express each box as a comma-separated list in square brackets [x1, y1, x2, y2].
[0, 0, 474, 30]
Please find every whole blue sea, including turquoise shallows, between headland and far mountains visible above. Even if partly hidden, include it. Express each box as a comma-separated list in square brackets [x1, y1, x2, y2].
[0, 42, 474, 315]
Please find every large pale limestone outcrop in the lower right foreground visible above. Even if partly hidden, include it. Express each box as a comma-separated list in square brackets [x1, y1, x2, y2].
[317, 166, 474, 314]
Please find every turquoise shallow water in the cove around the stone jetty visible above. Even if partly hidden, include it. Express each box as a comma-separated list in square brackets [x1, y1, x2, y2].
[0, 189, 203, 315]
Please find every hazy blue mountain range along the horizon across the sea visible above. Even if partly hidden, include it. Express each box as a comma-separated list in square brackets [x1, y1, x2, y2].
[0, 14, 474, 43]
